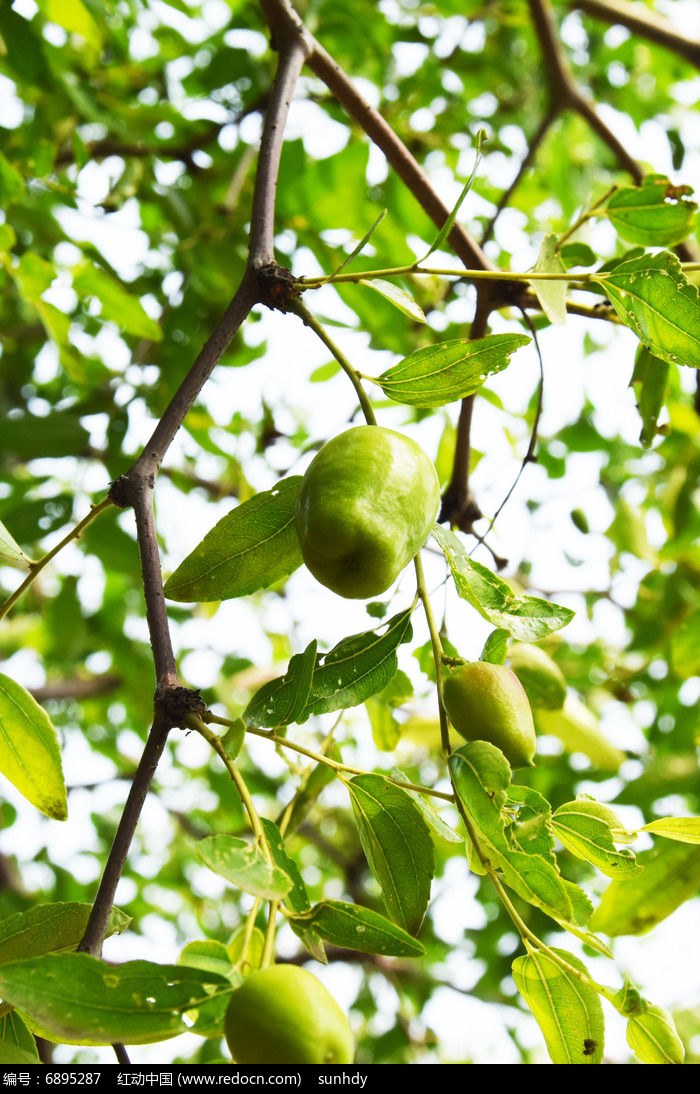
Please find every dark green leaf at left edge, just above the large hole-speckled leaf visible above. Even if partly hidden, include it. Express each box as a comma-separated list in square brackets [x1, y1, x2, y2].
[0, 901, 131, 965]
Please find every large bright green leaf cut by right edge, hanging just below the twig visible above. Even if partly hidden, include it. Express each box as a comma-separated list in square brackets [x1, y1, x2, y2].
[593, 251, 700, 369]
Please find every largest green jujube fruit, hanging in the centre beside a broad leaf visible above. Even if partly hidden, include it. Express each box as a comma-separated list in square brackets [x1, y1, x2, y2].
[296, 426, 440, 600]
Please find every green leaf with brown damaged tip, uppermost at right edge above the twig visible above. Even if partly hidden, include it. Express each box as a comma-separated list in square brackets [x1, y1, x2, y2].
[605, 175, 698, 247]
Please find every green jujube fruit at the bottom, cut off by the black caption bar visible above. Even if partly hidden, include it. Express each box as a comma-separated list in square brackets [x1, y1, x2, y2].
[224, 965, 354, 1064]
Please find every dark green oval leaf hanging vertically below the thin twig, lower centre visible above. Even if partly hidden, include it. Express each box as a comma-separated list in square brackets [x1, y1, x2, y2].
[347, 775, 434, 934]
